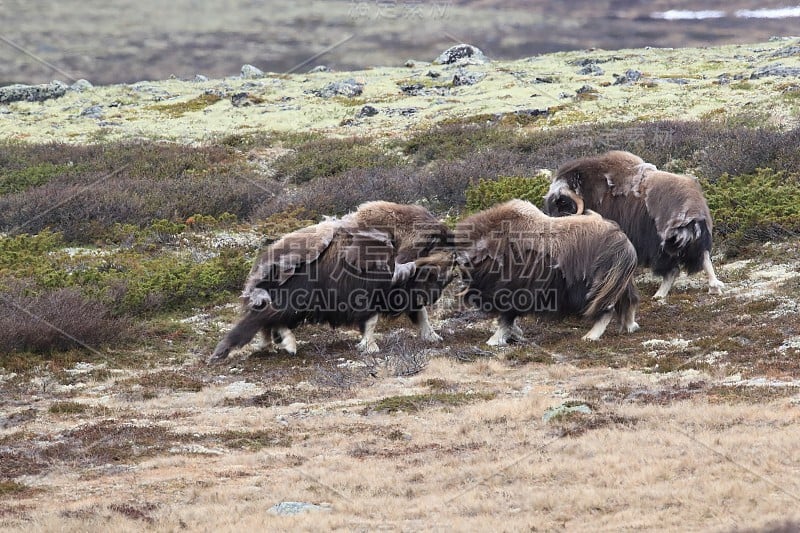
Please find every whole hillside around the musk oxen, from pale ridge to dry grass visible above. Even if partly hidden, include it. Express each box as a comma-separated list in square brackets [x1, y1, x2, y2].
[0, 40, 800, 531]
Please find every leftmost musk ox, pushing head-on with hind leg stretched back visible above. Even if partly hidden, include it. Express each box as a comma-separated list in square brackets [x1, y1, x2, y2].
[209, 202, 455, 362]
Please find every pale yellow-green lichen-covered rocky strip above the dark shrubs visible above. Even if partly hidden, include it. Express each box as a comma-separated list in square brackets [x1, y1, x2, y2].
[0, 39, 800, 143]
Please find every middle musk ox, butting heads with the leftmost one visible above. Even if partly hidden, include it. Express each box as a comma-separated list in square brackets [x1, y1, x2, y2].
[455, 200, 639, 346]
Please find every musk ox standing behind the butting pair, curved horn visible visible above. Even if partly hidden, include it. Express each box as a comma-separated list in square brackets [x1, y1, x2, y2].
[544, 151, 724, 300]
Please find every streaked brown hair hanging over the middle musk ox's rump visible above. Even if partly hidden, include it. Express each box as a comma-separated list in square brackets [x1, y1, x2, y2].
[582, 232, 638, 319]
